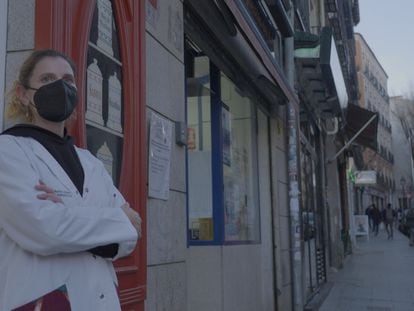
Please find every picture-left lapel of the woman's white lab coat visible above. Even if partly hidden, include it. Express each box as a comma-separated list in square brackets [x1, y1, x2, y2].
[32, 141, 77, 193]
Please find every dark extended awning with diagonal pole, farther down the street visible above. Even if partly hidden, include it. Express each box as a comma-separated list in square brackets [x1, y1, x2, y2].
[345, 105, 378, 151]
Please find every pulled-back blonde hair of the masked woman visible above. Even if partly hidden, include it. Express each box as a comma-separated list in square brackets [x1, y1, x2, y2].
[6, 50, 76, 123]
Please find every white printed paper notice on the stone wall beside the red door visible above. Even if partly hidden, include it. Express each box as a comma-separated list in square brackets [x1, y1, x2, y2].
[148, 113, 172, 200]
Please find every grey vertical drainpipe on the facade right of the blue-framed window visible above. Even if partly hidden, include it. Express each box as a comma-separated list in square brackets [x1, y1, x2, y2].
[284, 4, 303, 311]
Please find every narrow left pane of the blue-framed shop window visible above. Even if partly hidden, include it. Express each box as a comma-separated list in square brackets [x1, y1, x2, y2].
[187, 56, 214, 241]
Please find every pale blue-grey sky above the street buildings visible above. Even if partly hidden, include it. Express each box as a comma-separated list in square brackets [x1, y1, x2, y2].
[354, 0, 414, 97]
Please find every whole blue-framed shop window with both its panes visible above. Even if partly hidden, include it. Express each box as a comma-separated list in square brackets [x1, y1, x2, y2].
[185, 39, 260, 244]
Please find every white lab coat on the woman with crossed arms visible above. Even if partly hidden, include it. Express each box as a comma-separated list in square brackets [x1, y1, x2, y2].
[0, 135, 137, 311]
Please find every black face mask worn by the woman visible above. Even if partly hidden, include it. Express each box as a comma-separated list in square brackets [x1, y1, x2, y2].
[27, 79, 78, 122]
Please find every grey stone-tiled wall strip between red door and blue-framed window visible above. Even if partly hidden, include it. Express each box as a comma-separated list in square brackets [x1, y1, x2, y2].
[145, 0, 187, 311]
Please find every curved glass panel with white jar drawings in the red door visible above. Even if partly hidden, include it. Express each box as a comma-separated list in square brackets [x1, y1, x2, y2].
[85, 0, 123, 186]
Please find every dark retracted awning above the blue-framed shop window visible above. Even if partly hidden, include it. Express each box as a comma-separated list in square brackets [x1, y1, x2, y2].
[185, 0, 298, 107]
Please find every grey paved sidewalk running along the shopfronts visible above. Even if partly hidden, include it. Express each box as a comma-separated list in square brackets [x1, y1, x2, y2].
[319, 229, 414, 311]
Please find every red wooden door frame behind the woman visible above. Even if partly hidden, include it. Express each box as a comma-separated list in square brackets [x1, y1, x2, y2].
[35, 0, 147, 310]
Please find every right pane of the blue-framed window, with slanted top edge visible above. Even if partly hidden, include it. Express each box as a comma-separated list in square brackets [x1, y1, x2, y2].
[220, 74, 259, 241]
